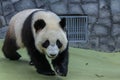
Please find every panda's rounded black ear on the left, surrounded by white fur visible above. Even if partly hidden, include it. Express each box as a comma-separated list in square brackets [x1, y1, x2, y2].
[34, 19, 46, 32]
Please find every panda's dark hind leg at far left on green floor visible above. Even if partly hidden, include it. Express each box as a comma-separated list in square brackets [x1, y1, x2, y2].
[2, 37, 21, 60]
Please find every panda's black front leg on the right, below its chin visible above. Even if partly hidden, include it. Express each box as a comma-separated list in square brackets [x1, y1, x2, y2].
[52, 48, 69, 76]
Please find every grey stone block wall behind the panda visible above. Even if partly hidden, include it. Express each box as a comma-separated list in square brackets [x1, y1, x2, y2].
[0, 0, 120, 52]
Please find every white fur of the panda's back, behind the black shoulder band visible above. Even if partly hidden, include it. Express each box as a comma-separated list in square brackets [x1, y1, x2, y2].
[9, 9, 39, 47]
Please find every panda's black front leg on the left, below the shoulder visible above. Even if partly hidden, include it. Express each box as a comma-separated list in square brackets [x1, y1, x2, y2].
[28, 48, 55, 75]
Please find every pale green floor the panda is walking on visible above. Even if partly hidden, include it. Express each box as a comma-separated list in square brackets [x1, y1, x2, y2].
[0, 40, 120, 80]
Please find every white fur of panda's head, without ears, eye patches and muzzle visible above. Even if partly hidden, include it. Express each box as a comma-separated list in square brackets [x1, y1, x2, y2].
[32, 11, 68, 54]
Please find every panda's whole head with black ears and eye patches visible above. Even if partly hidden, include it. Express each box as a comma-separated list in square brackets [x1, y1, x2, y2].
[32, 11, 68, 59]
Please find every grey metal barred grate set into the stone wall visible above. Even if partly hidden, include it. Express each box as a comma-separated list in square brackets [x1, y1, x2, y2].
[60, 14, 88, 43]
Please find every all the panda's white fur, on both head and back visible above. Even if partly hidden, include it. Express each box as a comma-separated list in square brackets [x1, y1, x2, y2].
[10, 9, 68, 55]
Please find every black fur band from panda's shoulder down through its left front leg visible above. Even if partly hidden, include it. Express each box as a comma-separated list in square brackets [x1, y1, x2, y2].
[22, 10, 55, 75]
